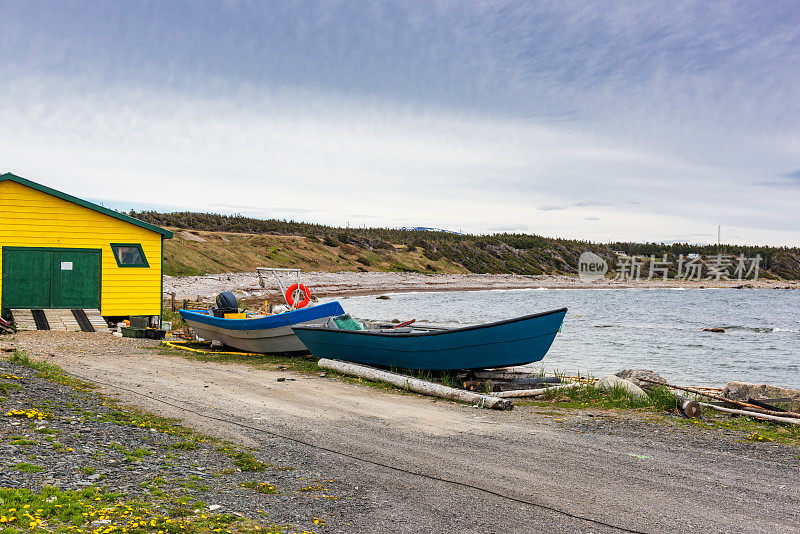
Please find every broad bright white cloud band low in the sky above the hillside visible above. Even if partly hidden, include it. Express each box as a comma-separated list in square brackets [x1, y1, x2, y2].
[0, 77, 798, 242]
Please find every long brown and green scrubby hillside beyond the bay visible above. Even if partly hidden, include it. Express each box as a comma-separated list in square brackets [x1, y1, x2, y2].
[130, 211, 800, 279]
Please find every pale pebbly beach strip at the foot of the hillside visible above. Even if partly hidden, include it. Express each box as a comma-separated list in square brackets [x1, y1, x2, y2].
[164, 271, 800, 300]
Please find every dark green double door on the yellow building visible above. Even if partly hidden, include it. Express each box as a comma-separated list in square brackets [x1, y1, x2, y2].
[2, 247, 100, 315]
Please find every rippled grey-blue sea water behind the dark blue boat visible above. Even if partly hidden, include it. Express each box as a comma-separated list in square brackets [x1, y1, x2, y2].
[318, 289, 800, 388]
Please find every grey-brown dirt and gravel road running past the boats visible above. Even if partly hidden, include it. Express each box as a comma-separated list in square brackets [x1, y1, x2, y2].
[7, 332, 800, 532]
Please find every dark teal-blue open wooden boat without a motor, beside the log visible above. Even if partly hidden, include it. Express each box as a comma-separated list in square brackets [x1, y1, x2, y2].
[292, 308, 567, 371]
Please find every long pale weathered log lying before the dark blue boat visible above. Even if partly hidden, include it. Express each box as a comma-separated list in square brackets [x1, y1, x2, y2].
[317, 358, 514, 410]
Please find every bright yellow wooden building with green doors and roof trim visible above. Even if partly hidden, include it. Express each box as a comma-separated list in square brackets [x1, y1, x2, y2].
[0, 173, 172, 318]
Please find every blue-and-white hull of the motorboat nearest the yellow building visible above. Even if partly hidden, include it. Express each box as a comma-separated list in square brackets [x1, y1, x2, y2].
[179, 302, 344, 353]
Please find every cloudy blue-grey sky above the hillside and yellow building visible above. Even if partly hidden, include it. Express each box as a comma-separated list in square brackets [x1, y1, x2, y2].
[0, 0, 800, 246]
